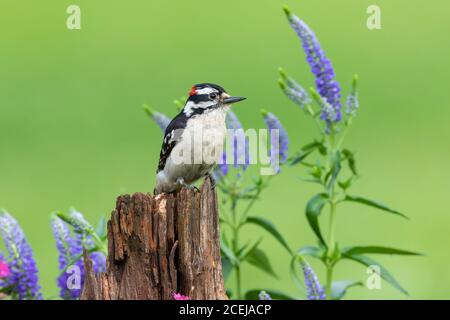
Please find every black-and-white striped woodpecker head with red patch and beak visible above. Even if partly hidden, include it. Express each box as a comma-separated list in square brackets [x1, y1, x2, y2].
[183, 83, 245, 116]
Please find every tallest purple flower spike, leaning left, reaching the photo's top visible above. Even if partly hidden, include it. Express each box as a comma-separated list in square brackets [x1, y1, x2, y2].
[285, 8, 341, 122]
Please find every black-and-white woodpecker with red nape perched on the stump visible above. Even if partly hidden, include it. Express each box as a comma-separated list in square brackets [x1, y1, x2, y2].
[154, 83, 246, 194]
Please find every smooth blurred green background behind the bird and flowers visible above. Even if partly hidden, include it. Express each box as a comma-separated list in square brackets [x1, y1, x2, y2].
[0, 0, 450, 299]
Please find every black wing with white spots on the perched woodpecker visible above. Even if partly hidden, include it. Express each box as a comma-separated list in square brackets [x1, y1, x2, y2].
[156, 112, 187, 173]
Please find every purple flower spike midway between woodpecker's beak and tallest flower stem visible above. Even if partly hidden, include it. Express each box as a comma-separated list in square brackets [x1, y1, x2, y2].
[261, 110, 289, 173]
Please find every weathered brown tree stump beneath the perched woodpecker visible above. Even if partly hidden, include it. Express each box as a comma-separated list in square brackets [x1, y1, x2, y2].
[80, 177, 228, 300]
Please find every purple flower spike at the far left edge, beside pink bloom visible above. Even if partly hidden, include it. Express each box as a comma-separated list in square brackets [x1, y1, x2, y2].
[0, 212, 42, 300]
